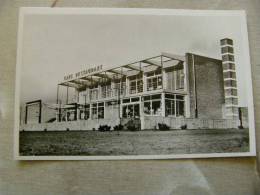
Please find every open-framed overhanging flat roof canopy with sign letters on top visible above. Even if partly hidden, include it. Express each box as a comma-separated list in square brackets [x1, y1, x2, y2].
[58, 52, 185, 88]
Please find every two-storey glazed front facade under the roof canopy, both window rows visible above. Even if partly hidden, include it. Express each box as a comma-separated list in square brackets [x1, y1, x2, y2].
[61, 58, 185, 120]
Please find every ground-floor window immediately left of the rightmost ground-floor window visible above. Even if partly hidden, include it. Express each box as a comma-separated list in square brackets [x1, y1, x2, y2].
[144, 94, 162, 115]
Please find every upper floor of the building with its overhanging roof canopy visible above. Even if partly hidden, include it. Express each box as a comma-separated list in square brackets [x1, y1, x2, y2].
[57, 53, 187, 104]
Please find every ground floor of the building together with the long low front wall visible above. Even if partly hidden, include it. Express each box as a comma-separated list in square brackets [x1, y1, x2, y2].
[20, 92, 248, 131]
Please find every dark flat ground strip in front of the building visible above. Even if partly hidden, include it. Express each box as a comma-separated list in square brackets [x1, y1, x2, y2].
[20, 129, 249, 155]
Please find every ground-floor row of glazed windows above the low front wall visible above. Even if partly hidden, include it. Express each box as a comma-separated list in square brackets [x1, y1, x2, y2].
[57, 93, 189, 122]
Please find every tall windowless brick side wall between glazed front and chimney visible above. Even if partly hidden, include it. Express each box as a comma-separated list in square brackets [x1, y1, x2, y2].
[186, 53, 225, 119]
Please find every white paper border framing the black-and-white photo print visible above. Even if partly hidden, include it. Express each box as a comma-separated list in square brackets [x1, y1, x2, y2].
[14, 7, 256, 160]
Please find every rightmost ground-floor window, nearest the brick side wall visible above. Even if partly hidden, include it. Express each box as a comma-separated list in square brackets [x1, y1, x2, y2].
[165, 94, 185, 117]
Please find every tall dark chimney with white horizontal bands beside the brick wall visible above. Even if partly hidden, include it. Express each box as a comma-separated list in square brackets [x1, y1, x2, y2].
[220, 38, 238, 119]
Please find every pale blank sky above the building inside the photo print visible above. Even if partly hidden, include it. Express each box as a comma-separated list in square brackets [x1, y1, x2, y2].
[20, 9, 249, 106]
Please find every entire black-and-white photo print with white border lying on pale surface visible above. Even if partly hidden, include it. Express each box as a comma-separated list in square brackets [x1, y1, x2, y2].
[14, 8, 255, 160]
